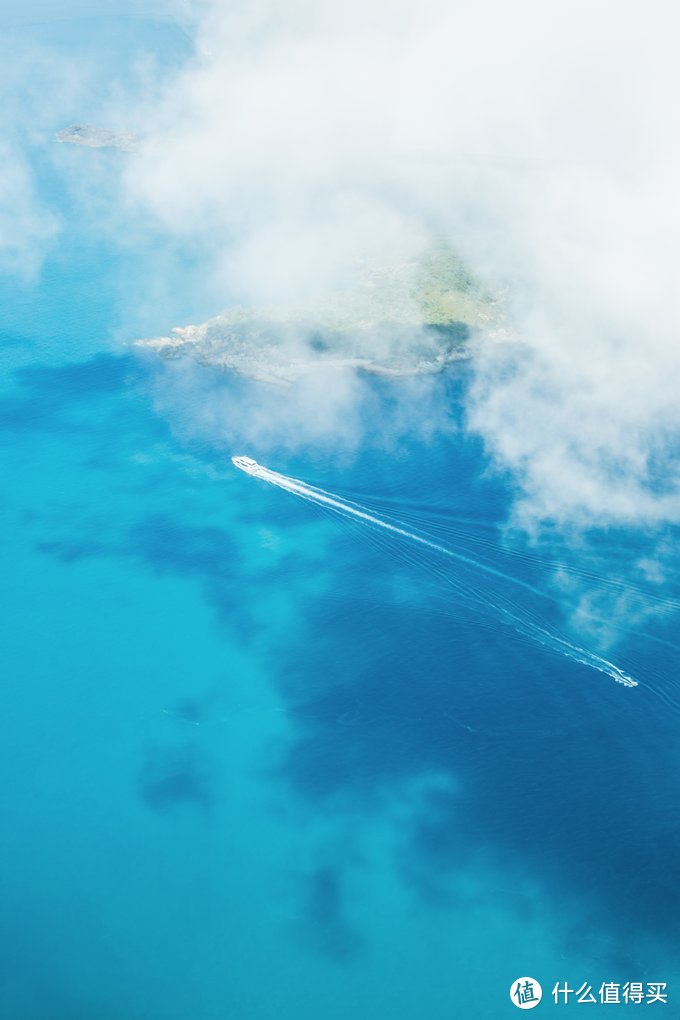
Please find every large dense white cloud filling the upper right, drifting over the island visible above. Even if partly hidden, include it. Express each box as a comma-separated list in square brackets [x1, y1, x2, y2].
[122, 0, 680, 522]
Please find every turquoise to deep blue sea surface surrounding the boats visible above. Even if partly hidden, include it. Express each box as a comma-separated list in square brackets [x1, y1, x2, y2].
[0, 9, 680, 1020]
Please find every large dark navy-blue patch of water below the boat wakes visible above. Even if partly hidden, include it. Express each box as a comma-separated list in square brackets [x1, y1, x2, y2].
[273, 507, 680, 941]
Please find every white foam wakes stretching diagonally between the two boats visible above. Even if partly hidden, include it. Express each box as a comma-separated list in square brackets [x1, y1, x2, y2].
[231, 457, 638, 687]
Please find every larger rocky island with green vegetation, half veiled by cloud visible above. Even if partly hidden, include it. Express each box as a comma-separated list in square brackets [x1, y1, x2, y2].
[138, 246, 508, 384]
